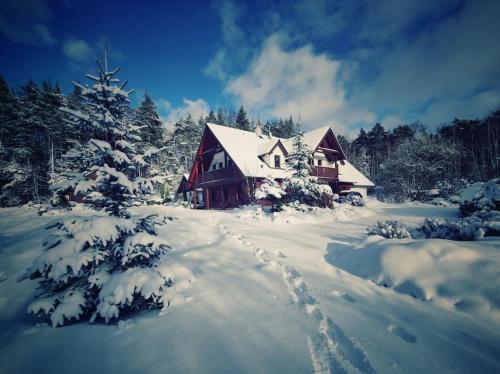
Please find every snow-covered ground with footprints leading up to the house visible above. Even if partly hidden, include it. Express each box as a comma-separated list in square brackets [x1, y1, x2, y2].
[0, 201, 500, 373]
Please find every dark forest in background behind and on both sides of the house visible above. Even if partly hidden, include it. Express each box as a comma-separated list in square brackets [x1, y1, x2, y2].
[0, 72, 500, 206]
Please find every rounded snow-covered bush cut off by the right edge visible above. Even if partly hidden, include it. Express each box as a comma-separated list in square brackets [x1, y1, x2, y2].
[460, 178, 500, 216]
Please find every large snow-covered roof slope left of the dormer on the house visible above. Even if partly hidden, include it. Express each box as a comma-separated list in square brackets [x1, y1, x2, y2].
[207, 123, 289, 178]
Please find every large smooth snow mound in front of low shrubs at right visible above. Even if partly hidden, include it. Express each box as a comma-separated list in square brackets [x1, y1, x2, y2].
[325, 236, 500, 320]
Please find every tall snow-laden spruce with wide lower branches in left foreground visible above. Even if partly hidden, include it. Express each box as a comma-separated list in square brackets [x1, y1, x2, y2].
[23, 54, 170, 326]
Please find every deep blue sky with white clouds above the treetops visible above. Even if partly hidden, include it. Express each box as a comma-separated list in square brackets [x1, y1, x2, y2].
[0, 0, 500, 136]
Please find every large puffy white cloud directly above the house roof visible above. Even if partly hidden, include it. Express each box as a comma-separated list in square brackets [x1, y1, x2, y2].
[226, 35, 374, 131]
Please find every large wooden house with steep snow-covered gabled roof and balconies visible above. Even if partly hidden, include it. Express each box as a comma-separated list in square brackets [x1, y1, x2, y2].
[179, 123, 373, 209]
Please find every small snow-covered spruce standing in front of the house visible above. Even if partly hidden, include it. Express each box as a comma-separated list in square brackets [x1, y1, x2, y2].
[282, 133, 333, 208]
